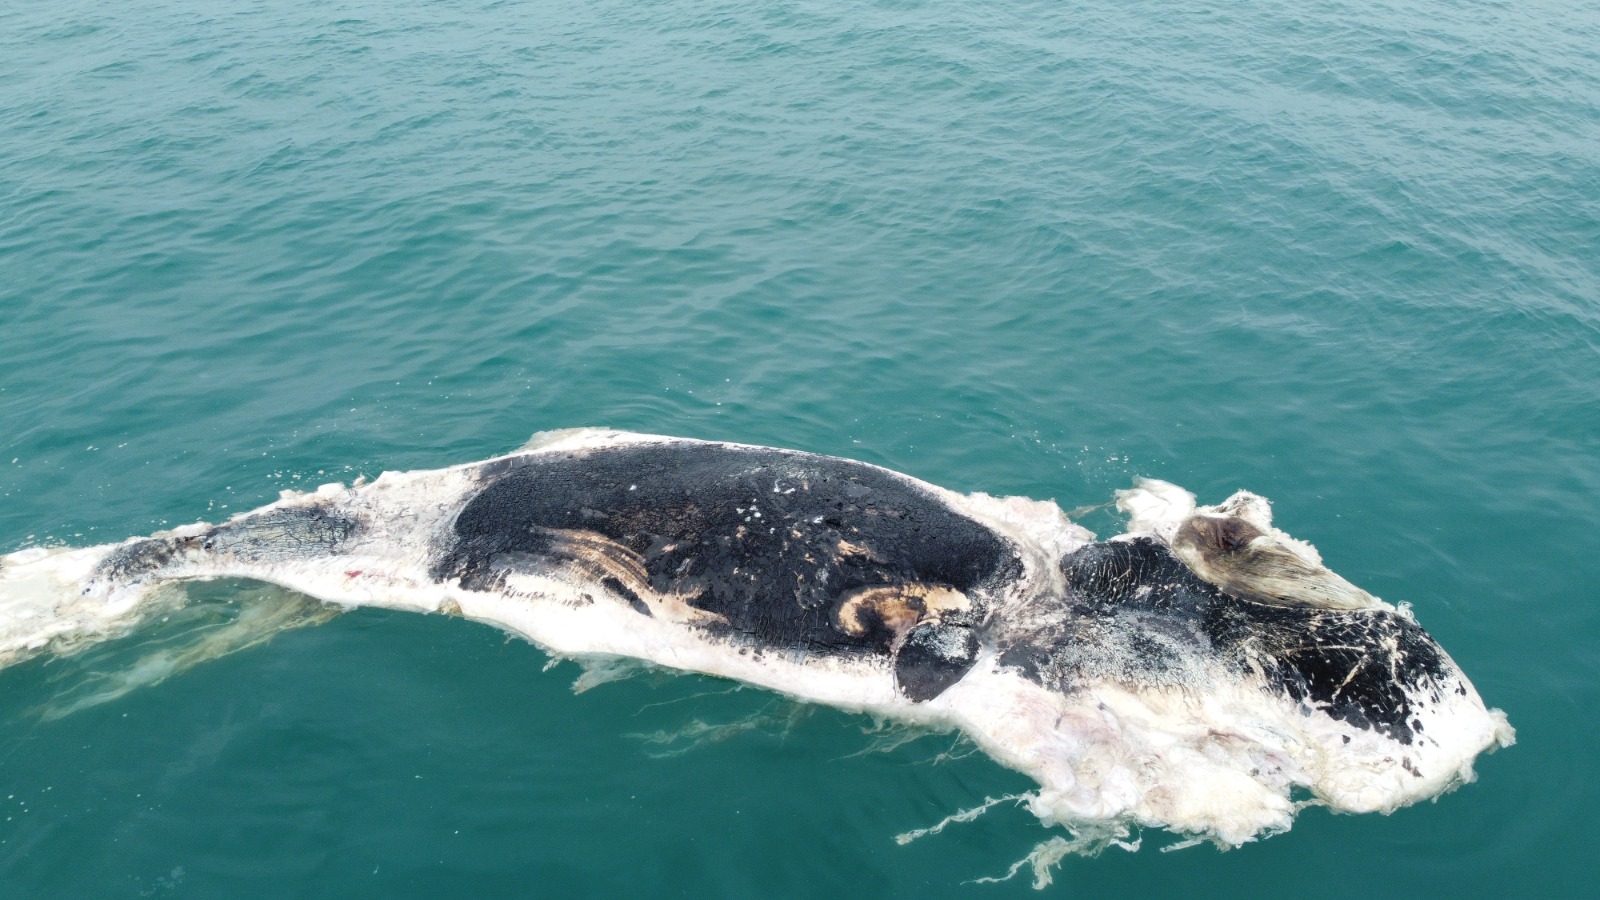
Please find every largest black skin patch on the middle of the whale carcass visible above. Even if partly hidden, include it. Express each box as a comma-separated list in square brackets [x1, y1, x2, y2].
[432, 444, 1022, 700]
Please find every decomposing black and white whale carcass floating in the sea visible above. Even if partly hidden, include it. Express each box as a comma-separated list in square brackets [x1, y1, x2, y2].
[0, 429, 1512, 871]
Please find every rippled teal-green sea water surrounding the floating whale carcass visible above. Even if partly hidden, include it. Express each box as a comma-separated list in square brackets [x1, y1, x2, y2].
[0, 0, 1600, 898]
